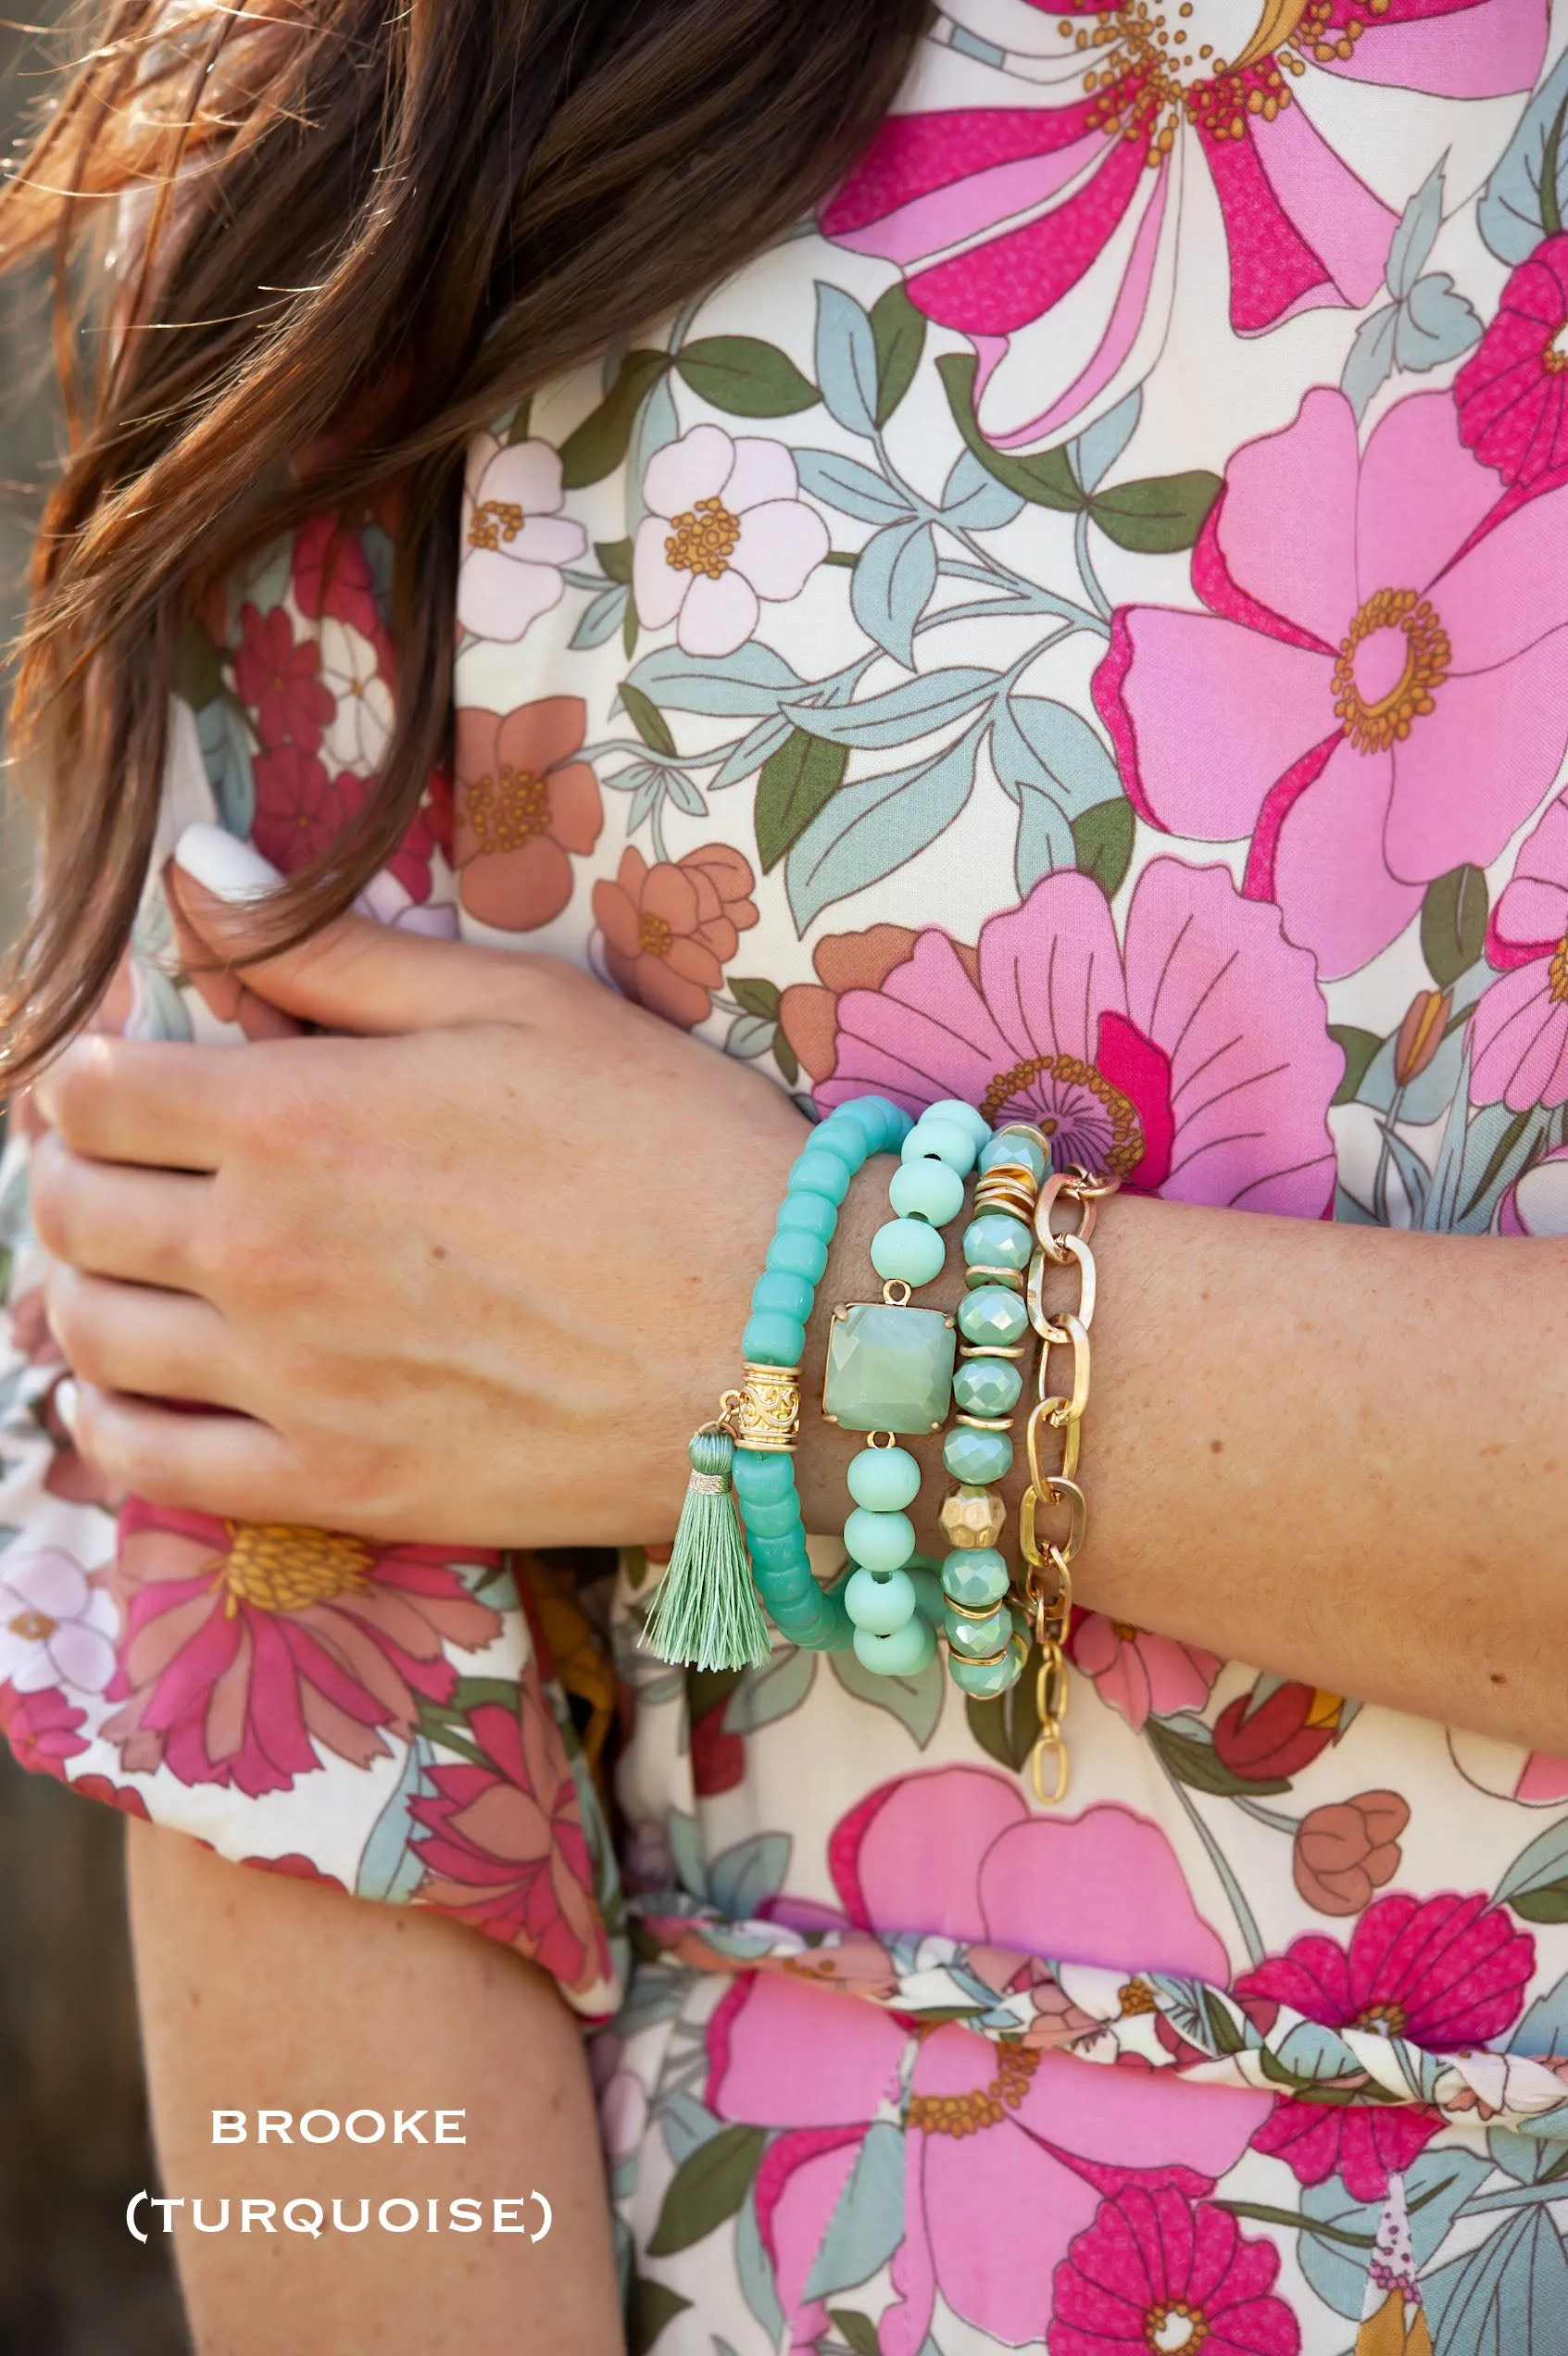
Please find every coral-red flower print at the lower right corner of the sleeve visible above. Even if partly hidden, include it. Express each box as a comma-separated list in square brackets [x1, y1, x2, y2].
[410, 1687, 610, 1988]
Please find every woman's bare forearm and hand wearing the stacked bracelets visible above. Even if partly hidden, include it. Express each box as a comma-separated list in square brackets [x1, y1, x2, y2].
[38, 884, 1568, 1750]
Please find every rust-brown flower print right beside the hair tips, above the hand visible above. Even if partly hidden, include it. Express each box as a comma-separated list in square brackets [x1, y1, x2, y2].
[453, 695, 604, 933]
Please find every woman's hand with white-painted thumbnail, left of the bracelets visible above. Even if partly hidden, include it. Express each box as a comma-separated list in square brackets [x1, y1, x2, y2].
[33, 847, 807, 1546]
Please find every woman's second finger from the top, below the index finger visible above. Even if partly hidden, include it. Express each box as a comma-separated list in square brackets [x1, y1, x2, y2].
[29, 1131, 212, 1291]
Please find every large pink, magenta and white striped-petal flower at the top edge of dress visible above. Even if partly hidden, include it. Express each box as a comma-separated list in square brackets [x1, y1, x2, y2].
[823, 0, 1547, 447]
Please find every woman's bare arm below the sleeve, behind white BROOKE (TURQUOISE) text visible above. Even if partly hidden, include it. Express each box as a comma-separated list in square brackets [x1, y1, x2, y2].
[130, 1823, 622, 2356]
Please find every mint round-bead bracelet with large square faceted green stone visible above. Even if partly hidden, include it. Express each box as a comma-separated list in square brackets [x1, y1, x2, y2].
[839, 1100, 990, 1677]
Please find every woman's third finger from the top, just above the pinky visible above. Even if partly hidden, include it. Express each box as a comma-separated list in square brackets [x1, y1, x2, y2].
[44, 1263, 245, 1409]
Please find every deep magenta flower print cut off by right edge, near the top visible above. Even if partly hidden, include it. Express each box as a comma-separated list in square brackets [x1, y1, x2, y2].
[1455, 235, 1568, 485]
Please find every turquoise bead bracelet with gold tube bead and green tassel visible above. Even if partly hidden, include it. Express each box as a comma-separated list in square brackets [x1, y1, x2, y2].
[641, 1096, 909, 1668]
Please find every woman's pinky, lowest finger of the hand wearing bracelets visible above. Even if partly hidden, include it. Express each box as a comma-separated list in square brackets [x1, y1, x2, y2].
[73, 1383, 301, 1522]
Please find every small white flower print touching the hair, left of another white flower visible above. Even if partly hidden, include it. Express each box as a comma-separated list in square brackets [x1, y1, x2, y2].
[458, 433, 587, 641]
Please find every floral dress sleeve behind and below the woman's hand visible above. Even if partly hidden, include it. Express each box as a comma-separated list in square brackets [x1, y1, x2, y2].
[0, 519, 625, 2019]
